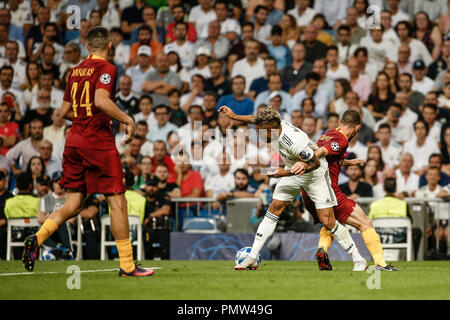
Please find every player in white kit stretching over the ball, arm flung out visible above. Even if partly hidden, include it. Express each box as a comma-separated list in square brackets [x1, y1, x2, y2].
[219, 106, 366, 270]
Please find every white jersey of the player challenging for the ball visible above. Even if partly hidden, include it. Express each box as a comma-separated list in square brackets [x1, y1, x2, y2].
[278, 120, 318, 169]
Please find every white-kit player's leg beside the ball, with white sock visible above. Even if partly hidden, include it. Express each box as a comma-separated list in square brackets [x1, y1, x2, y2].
[234, 199, 290, 270]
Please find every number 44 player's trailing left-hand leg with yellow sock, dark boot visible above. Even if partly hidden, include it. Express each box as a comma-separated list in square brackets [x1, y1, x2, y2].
[22, 190, 84, 271]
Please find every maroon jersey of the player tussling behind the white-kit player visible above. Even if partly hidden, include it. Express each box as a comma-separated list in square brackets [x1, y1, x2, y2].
[317, 130, 348, 194]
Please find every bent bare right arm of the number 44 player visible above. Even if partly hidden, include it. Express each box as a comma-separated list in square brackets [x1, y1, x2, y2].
[95, 89, 136, 144]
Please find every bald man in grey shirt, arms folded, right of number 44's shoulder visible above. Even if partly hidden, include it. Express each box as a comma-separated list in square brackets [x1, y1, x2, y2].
[142, 50, 181, 105]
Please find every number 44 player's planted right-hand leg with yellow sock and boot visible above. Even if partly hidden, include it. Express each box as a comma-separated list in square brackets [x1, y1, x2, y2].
[106, 193, 154, 276]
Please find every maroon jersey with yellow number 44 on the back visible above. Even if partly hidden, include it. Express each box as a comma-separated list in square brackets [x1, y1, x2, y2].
[64, 55, 117, 150]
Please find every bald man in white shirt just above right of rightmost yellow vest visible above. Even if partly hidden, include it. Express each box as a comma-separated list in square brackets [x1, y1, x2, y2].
[395, 153, 420, 199]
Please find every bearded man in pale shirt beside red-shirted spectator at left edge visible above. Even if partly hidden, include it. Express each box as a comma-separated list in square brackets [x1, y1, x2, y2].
[6, 119, 44, 174]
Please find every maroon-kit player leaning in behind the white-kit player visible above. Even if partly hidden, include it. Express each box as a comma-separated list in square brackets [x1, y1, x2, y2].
[302, 110, 397, 271]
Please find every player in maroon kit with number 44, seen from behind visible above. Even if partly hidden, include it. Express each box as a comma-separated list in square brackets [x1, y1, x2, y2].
[22, 27, 154, 276]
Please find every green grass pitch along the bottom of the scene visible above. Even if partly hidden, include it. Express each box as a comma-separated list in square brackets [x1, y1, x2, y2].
[0, 261, 450, 300]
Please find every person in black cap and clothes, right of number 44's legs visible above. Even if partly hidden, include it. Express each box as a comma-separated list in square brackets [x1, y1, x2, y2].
[143, 174, 172, 259]
